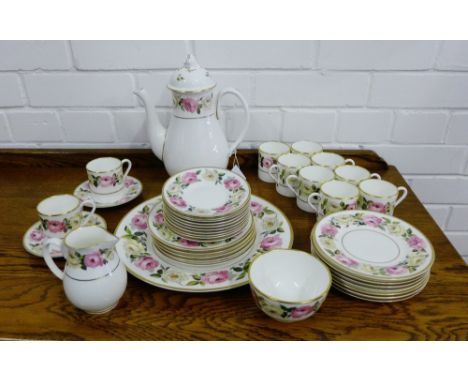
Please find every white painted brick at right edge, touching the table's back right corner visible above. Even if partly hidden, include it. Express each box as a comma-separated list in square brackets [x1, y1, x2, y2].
[375, 146, 465, 174]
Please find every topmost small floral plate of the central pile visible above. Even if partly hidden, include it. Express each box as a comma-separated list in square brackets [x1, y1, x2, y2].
[162, 168, 250, 217]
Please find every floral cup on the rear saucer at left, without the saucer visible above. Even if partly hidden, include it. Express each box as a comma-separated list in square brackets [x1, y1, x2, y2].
[86, 157, 132, 196]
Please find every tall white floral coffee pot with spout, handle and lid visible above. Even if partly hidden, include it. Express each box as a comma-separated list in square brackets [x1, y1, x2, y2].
[136, 54, 250, 175]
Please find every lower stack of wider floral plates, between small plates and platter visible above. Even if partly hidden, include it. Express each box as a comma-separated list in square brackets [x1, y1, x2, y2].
[148, 199, 256, 265]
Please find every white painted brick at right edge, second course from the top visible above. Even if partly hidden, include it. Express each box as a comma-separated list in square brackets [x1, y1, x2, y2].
[369, 73, 468, 108]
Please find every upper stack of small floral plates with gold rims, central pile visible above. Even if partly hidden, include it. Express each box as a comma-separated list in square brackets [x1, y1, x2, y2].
[162, 168, 252, 242]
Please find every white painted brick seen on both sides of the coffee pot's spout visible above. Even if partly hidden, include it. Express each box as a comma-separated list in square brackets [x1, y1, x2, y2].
[114, 110, 170, 143]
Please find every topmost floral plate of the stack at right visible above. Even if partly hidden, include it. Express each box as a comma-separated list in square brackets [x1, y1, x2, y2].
[312, 211, 435, 280]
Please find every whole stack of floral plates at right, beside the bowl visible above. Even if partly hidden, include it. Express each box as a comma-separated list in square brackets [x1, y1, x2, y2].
[311, 210, 435, 302]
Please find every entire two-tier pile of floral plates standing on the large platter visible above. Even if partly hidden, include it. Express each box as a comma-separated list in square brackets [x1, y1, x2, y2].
[148, 168, 256, 266]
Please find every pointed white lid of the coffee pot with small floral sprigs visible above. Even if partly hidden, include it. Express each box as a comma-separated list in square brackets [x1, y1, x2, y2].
[167, 54, 216, 93]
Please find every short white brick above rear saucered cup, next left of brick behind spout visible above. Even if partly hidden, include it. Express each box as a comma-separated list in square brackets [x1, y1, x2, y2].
[60, 111, 114, 143]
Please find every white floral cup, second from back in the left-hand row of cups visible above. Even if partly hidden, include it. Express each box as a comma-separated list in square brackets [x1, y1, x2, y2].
[269, 154, 310, 198]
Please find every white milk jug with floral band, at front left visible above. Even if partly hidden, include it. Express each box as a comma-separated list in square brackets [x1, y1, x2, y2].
[44, 226, 127, 314]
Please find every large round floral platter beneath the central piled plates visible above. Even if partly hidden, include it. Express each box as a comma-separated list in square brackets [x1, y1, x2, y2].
[115, 195, 293, 293]
